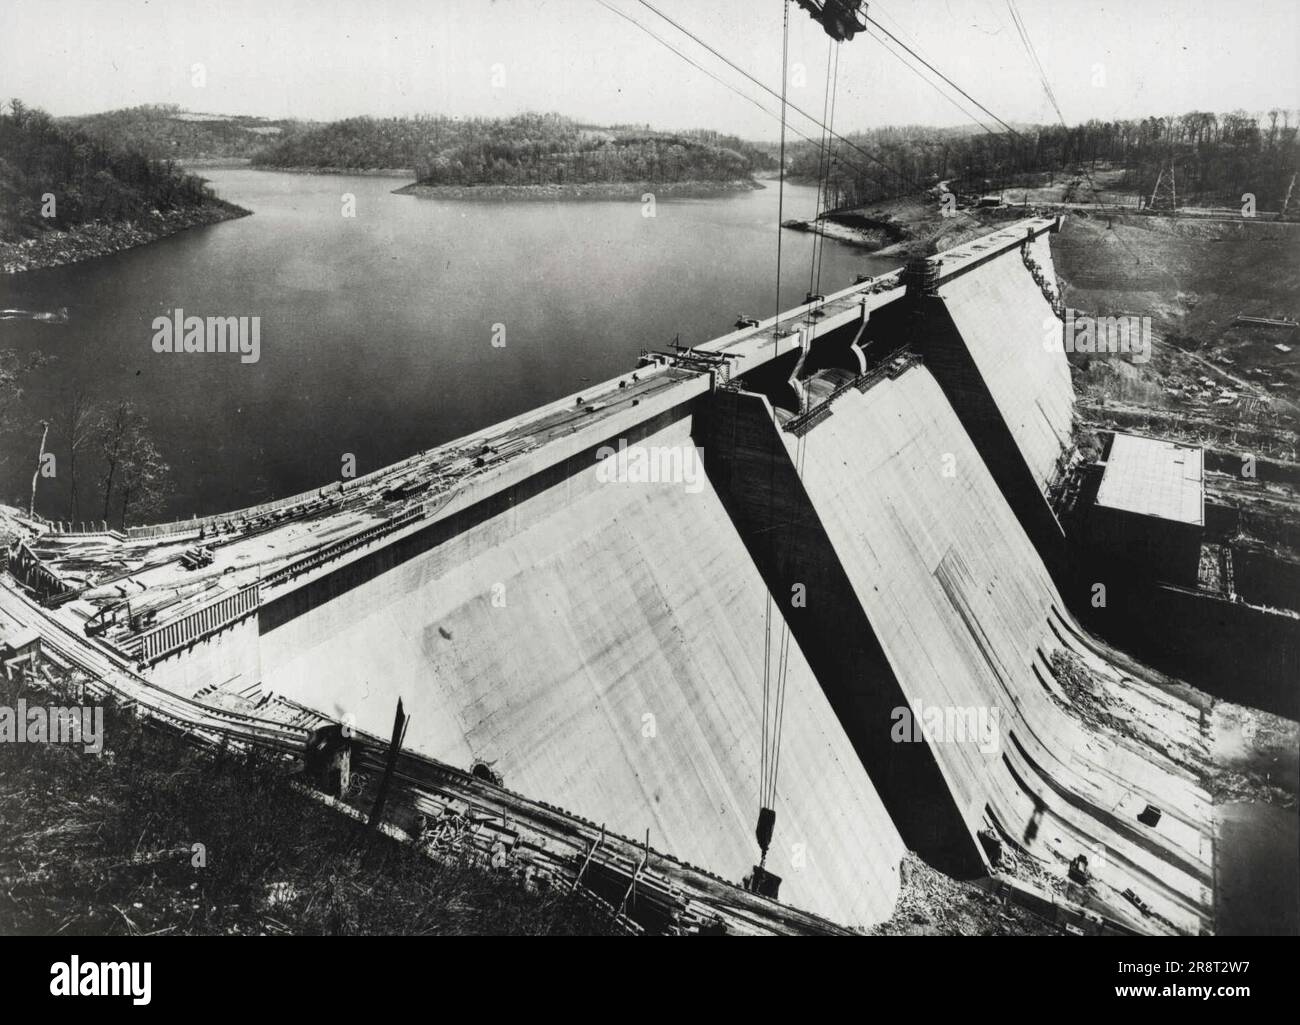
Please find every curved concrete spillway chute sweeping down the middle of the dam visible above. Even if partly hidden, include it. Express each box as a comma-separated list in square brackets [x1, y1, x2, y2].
[743, 367, 1212, 933]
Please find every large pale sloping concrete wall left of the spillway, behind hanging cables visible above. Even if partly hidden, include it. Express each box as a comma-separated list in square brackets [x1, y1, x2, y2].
[253, 395, 904, 925]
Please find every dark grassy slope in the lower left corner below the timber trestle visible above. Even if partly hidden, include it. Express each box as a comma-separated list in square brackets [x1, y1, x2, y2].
[0, 680, 616, 935]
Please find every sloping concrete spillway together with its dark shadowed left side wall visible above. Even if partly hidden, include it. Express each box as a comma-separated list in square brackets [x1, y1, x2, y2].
[715, 368, 1210, 933]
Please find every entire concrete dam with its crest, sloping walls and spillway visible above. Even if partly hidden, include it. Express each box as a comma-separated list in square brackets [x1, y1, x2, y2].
[10, 219, 1214, 934]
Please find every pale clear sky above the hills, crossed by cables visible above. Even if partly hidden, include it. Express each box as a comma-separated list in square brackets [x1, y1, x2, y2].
[0, 0, 1300, 139]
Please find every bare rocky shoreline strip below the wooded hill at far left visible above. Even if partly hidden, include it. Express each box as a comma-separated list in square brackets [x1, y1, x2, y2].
[0, 199, 252, 274]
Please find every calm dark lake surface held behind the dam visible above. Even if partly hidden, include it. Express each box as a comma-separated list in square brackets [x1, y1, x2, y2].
[0, 169, 897, 519]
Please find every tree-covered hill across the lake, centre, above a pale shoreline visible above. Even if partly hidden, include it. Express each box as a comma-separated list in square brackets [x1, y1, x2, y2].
[254, 114, 776, 186]
